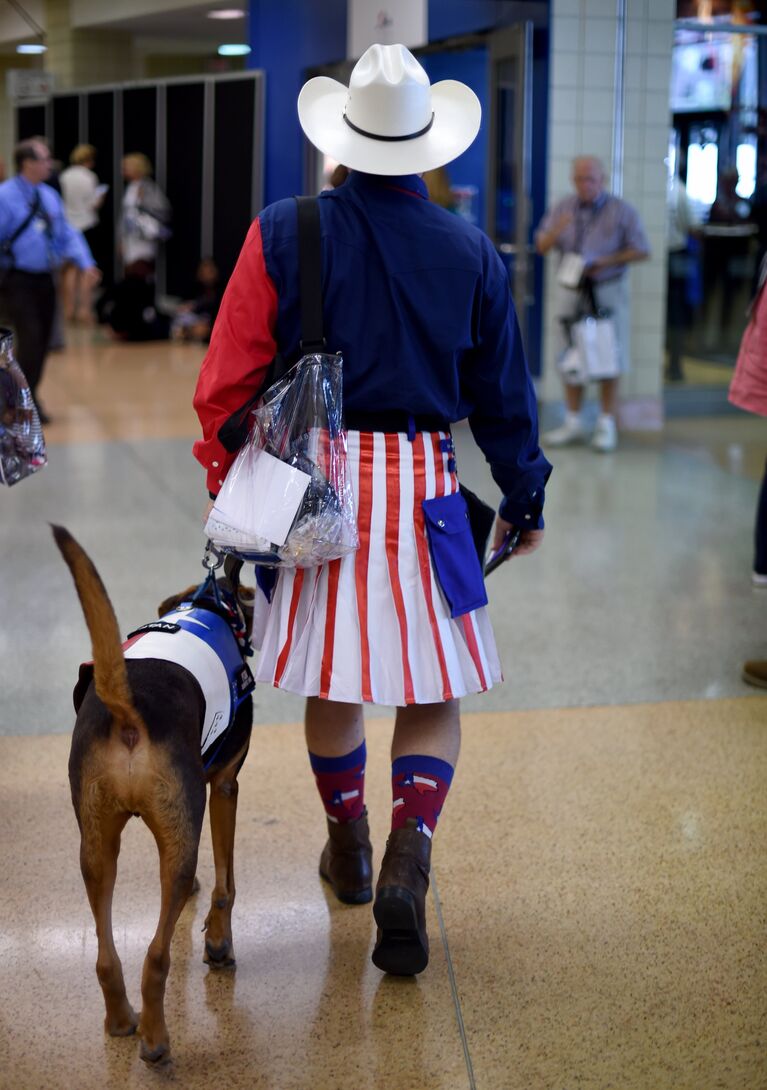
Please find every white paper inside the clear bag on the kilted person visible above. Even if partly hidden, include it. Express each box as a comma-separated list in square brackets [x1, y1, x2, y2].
[211, 447, 312, 545]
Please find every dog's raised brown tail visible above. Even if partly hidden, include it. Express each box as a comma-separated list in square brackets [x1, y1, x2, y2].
[51, 524, 146, 750]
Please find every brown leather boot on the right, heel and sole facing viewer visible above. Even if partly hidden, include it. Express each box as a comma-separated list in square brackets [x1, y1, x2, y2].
[373, 826, 431, 977]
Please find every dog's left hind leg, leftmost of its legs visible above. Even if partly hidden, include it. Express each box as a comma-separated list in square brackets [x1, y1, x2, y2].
[77, 807, 138, 1037]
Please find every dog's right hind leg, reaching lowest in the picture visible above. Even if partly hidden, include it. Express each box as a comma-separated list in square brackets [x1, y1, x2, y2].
[138, 783, 205, 1066]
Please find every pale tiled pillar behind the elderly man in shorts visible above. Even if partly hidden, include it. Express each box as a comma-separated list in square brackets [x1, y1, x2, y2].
[541, 0, 675, 426]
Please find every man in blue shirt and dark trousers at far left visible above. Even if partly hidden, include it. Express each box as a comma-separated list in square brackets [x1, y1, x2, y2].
[0, 138, 101, 424]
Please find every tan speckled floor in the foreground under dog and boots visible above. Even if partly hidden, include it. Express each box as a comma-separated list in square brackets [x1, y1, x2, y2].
[0, 697, 767, 1090]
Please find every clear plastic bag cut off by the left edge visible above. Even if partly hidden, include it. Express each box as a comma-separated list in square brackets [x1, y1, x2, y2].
[0, 328, 48, 485]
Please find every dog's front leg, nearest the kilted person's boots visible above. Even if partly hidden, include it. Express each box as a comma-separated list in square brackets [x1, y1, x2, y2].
[203, 746, 247, 969]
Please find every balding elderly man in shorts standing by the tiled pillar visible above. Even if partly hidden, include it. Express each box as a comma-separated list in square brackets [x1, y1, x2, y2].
[535, 156, 649, 452]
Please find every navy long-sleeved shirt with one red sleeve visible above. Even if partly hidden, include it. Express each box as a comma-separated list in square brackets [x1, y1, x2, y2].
[195, 171, 551, 529]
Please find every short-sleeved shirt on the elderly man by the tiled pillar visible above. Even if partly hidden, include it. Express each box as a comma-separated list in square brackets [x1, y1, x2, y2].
[538, 193, 649, 280]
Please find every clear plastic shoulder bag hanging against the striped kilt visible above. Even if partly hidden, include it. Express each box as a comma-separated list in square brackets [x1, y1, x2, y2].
[205, 353, 360, 568]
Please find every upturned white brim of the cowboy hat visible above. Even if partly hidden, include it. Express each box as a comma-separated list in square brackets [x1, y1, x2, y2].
[299, 75, 482, 174]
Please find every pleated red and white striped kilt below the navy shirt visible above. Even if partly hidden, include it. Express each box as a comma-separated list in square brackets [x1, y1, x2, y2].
[254, 432, 501, 706]
